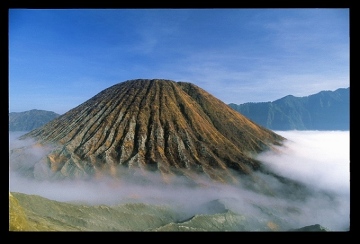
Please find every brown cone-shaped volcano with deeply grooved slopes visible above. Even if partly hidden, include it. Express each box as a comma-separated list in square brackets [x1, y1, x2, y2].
[21, 79, 285, 181]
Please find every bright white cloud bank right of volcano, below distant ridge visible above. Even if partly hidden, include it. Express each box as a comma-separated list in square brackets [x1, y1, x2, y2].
[259, 131, 350, 194]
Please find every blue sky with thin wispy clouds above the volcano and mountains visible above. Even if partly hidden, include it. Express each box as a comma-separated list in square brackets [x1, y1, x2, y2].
[9, 8, 350, 114]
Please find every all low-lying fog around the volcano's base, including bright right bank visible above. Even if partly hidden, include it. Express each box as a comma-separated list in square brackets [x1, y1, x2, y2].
[9, 131, 350, 231]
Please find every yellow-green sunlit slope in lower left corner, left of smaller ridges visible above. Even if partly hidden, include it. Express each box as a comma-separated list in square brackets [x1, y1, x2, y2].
[10, 192, 179, 231]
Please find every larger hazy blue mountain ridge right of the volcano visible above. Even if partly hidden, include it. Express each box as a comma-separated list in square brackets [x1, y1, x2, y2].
[229, 88, 350, 130]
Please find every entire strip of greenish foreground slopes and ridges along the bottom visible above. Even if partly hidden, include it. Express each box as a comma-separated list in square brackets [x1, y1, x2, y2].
[9, 192, 296, 231]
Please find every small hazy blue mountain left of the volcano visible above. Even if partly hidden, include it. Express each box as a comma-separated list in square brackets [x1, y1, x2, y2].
[9, 109, 60, 131]
